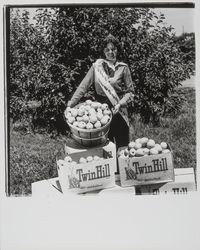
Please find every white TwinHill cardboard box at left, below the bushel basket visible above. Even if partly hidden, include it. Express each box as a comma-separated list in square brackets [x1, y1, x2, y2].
[57, 148, 116, 194]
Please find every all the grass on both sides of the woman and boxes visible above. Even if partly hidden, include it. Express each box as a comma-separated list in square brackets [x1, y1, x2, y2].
[9, 88, 196, 195]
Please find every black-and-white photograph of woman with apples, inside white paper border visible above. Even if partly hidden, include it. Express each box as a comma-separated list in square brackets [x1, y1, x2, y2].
[5, 3, 196, 196]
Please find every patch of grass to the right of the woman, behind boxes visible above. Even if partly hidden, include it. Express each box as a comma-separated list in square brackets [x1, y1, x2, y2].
[131, 88, 196, 168]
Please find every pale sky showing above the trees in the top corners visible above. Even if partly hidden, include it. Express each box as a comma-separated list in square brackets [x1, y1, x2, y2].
[21, 8, 195, 35]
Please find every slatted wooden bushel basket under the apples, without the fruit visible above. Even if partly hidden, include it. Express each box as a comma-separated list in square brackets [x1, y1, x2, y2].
[67, 105, 112, 147]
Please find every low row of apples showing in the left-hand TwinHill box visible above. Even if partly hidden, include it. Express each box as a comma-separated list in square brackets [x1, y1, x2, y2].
[58, 155, 104, 166]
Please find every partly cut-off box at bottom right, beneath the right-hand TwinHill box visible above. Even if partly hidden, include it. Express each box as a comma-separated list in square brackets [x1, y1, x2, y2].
[136, 168, 196, 195]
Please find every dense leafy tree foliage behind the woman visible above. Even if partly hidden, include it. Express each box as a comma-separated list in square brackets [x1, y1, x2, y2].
[10, 6, 194, 132]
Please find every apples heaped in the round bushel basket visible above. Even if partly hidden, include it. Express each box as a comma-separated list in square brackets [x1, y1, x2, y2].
[65, 100, 112, 129]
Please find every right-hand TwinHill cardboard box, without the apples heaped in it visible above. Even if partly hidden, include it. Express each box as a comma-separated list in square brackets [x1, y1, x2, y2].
[118, 149, 174, 187]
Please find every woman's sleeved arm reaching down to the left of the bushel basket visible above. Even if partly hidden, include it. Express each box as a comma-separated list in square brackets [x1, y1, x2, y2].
[67, 66, 94, 107]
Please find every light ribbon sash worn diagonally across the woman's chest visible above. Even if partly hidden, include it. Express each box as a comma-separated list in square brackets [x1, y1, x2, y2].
[94, 60, 129, 126]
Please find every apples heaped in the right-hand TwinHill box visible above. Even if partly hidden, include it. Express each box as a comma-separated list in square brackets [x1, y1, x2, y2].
[118, 137, 170, 158]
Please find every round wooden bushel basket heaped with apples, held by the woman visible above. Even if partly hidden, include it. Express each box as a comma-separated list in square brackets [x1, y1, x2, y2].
[64, 100, 112, 147]
